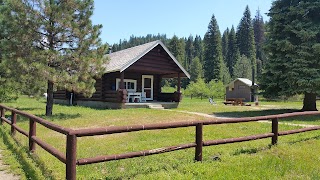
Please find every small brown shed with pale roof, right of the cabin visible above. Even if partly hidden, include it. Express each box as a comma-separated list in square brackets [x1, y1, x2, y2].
[226, 78, 259, 102]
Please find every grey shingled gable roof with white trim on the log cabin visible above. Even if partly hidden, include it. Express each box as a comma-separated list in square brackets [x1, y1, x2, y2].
[105, 40, 190, 78]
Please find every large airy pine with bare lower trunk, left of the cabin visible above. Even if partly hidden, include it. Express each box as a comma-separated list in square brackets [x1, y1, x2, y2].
[3, 0, 106, 116]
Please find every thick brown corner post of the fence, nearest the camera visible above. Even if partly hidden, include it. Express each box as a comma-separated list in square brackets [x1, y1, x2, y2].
[66, 135, 77, 180]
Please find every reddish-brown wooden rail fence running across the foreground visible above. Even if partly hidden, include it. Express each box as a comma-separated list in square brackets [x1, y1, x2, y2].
[0, 104, 320, 180]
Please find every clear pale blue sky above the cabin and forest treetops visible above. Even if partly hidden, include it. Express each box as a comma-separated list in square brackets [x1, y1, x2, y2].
[92, 0, 273, 44]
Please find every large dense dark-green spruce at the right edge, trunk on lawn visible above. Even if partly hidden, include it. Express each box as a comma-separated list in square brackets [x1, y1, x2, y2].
[261, 0, 320, 110]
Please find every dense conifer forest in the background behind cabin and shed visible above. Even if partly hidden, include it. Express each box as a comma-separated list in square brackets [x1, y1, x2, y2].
[110, 6, 266, 88]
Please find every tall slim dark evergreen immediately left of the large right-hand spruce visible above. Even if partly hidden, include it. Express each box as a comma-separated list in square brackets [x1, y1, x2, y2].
[253, 9, 266, 78]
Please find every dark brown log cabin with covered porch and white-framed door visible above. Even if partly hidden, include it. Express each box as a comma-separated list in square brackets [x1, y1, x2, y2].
[54, 40, 190, 109]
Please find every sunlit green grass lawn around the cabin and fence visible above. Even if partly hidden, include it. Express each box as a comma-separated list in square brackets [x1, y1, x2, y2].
[0, 98, 320, 179]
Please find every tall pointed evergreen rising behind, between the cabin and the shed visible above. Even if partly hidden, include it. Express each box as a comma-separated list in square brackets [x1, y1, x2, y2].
[204, 15, 223, 82]
